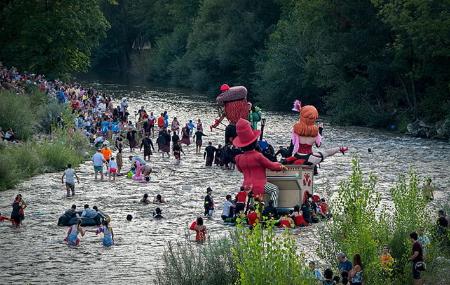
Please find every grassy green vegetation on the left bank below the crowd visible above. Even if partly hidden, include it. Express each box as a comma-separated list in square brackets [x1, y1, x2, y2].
[0, 88, 89, 190]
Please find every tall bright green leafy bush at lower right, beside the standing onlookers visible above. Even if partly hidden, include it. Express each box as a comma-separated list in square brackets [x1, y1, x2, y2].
[319, 159, 442, 285]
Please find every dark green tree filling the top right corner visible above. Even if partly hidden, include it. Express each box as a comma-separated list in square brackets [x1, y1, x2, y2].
[372, 0, 450, 121]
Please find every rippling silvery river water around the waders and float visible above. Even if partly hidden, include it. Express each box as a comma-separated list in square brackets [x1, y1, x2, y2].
[0, 81, 450, 284]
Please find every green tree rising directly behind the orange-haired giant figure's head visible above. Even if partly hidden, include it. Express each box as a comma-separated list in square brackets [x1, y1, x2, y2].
[253, 1, 325, 110]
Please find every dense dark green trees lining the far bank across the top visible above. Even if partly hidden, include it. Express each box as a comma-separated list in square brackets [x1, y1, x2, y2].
[0, 0, 450, 129]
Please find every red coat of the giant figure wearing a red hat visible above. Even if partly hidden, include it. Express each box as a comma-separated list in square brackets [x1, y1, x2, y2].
[236, 150, 282, 195]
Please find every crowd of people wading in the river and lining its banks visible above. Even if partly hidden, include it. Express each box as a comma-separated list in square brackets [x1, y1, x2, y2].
[0, 65, 448, 285]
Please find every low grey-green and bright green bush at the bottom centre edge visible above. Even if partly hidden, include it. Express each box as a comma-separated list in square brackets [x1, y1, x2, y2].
[157, 225, 317, 285]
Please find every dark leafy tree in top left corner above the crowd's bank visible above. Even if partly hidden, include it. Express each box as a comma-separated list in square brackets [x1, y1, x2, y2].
[0, 0, 109, 77]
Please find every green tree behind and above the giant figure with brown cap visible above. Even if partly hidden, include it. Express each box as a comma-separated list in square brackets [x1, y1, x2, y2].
[178, 0, 279, 93]
